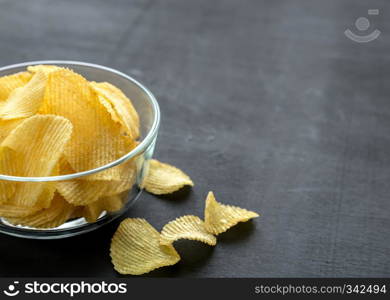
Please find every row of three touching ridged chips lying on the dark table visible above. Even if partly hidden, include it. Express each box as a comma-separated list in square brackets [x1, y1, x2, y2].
[110, 191, 259, 275]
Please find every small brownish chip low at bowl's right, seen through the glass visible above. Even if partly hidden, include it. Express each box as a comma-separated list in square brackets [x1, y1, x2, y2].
[83, 195, 123, 223]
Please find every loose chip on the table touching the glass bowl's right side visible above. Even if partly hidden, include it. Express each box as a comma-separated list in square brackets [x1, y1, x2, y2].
[142, 159, 194, 195]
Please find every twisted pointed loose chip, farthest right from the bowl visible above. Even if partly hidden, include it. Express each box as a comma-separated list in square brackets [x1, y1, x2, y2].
[205, 192, 259, 235]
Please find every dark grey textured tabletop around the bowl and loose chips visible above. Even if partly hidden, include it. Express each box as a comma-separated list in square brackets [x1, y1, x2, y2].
[0, 0, 390, 277]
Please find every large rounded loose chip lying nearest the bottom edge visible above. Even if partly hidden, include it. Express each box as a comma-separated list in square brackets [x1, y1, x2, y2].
[110, 219, 180, 275]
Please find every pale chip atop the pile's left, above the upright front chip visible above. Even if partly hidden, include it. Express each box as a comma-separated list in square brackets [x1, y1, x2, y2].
[0, 72, 47, 120]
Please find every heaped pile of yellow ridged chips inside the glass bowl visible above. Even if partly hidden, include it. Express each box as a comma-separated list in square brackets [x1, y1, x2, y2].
[0, 65, 140, 228]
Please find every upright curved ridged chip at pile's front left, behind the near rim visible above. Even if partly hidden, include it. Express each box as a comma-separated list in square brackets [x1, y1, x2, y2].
[0, 115, 72, 206]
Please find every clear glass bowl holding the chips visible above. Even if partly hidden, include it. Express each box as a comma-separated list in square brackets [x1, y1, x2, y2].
[0, 61, 160, 239]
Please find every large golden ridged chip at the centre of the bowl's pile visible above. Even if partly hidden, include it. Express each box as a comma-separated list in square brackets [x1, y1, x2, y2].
[40, 69, 135, 180]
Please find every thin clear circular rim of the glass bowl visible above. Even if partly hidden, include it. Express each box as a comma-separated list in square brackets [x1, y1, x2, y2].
[0, 60, 160, 182]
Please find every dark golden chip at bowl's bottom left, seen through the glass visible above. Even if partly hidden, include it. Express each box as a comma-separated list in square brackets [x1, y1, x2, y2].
[7, 194, 67, 228]
